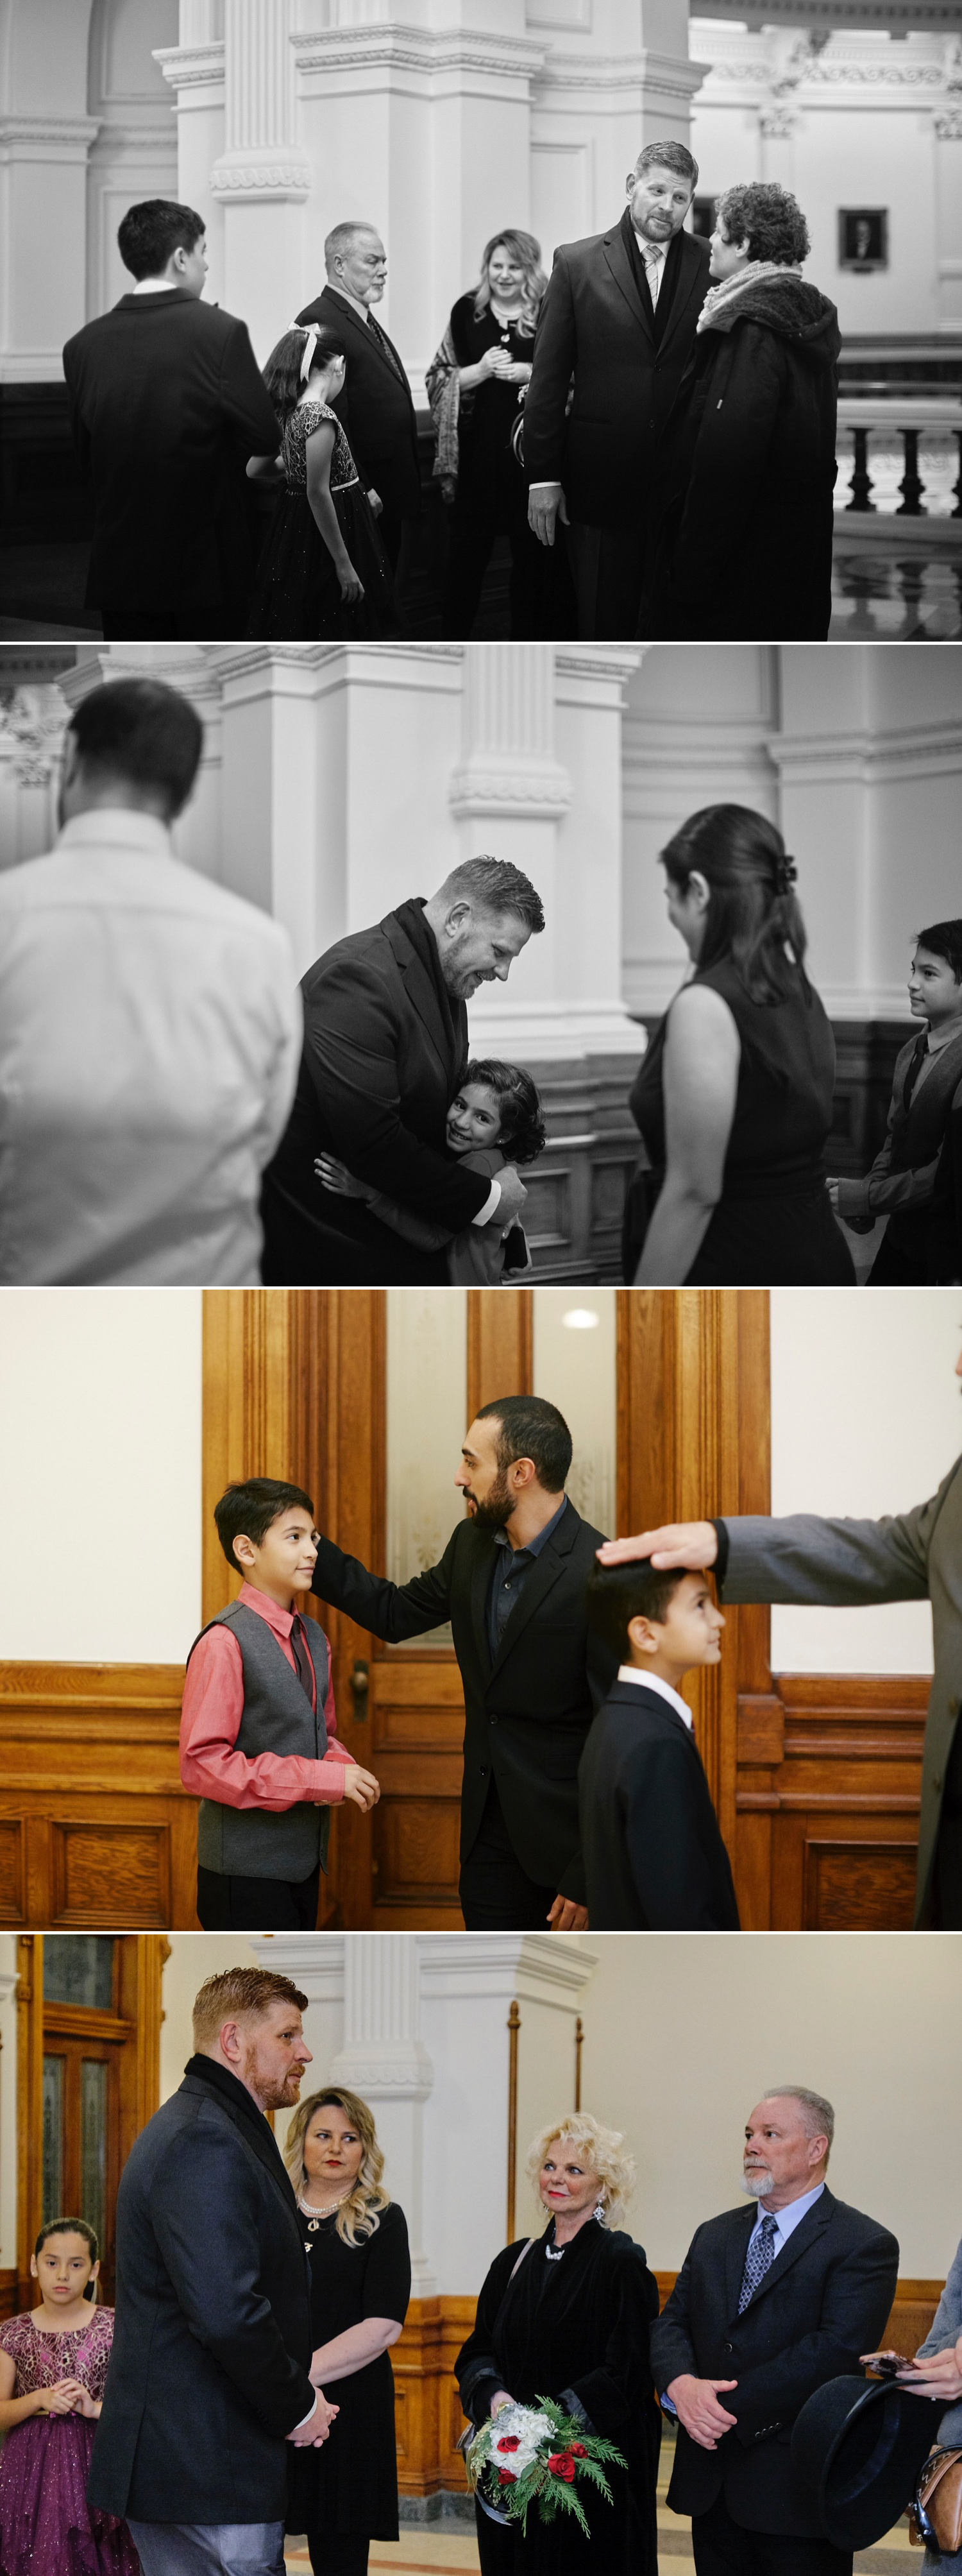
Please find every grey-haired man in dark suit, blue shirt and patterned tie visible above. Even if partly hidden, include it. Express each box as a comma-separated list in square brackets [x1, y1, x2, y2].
[651, 2084, 898, 2576]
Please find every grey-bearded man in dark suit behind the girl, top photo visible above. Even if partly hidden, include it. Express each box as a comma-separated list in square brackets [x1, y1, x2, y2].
[298, 224, 422, 572]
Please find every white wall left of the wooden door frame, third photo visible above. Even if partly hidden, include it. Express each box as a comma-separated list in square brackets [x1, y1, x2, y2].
[0, 1288, 201, 1664]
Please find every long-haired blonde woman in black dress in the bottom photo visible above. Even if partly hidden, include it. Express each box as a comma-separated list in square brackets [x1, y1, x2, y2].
[283, 2084, 412, 2576]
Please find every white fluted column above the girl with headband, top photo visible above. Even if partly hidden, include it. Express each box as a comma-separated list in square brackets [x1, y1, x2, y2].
[211, 0, 311, 363]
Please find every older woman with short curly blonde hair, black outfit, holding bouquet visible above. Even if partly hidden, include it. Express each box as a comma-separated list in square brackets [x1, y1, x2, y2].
[455, 2112, 661, 2576]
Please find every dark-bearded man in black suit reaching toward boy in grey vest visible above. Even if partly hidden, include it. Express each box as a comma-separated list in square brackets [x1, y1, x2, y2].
[314, 1396, 615, 1932]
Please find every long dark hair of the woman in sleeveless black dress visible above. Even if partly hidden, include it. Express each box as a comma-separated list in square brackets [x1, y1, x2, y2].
[661, 806, 807, 1002]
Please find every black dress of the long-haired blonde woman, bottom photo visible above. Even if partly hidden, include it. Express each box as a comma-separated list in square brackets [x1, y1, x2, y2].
[288, 2200, 412, 2568]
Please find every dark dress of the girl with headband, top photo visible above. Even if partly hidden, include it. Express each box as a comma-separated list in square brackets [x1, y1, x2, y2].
[247, 402, 404, 644]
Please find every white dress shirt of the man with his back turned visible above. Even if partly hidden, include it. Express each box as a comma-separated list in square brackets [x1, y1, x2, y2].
[0, 806, 301, 1288]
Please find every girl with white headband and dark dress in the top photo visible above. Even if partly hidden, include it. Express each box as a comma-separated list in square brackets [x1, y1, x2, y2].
[247, 322, 401, 642]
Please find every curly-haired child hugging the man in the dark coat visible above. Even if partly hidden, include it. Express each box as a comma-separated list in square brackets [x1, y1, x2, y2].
[314, 1059, 545, 1288]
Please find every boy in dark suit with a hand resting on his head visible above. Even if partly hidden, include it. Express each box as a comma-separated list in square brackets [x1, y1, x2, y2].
[578, 1564, 738, 1932]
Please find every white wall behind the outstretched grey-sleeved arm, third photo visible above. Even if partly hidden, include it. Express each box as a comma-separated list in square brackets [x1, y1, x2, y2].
[772, 1288, 962, 1672]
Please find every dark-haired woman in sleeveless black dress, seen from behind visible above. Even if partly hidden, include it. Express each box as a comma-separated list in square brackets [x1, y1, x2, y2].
[625, 806, 854, 1288]
